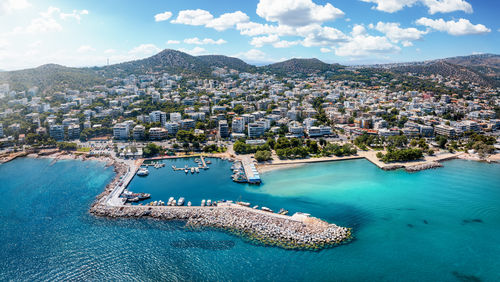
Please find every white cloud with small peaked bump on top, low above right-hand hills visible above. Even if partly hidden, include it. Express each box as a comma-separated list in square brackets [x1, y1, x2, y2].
[334, 25, 401, 57]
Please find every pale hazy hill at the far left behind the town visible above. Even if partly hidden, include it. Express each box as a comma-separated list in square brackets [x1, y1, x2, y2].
[0, 64, 104, 90]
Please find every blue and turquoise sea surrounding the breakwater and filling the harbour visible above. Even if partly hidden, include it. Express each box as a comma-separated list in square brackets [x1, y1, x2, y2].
[0, 159, 500, 281]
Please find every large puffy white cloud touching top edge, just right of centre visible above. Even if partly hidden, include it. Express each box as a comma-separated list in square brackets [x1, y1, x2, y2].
[257, 0, 344, 26]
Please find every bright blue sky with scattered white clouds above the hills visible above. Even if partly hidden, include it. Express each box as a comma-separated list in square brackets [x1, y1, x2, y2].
[0, 0, 500, 70]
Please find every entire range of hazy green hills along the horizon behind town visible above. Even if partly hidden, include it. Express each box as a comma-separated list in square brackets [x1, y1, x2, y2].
[0, 49, 500, 90]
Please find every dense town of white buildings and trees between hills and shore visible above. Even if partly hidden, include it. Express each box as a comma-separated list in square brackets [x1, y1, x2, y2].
[0, 60, 500, 166]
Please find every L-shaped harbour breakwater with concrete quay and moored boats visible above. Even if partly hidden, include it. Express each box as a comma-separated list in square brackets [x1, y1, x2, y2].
[91, 158, 351, 251]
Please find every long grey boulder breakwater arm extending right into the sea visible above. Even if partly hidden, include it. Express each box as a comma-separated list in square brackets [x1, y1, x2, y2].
[91, 204, 351, 250]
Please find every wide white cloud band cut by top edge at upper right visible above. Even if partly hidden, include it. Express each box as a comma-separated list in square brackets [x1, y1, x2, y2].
[361, 0, 472, 14]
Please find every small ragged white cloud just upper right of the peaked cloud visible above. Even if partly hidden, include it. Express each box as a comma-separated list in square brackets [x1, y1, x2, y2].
[370, 22, 428, 44]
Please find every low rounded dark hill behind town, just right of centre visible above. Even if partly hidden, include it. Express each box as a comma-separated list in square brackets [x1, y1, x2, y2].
[261, 59, 340, 74]
